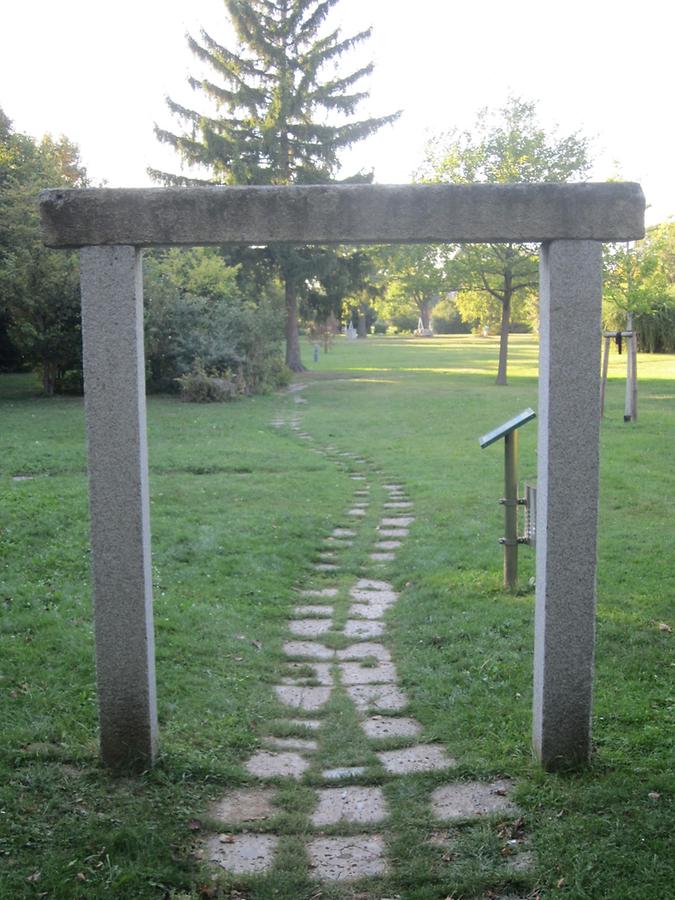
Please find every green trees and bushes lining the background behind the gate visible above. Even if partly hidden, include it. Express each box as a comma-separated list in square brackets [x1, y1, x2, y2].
[0, 0, 675, 396]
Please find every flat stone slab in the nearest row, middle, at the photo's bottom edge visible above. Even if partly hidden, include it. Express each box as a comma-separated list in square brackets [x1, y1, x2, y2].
[307, 834, 387, 881]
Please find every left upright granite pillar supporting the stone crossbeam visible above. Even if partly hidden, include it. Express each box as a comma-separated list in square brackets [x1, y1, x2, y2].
[80, 246, 157, 769]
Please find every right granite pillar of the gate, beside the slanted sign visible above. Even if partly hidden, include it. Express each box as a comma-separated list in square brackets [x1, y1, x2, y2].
[533, 240, 602, 770]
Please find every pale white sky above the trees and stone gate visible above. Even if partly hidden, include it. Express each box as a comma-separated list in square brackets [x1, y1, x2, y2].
[0, 0, 675, 224]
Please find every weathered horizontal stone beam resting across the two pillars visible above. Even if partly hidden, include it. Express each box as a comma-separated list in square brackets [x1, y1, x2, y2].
[40, 183, 645, 247]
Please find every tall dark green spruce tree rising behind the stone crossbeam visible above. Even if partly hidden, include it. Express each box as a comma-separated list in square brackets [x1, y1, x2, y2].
[149, 0, 398, 371]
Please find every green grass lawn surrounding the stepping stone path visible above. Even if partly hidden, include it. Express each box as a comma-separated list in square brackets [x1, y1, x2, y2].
[0, 336, 675, 900]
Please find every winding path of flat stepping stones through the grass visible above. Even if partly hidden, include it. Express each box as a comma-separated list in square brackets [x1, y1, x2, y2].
[204, 385, 535, 884]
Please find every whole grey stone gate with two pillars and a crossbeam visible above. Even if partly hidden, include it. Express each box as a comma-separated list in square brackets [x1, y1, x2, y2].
[40, 184, 645, 769]
